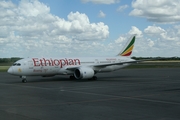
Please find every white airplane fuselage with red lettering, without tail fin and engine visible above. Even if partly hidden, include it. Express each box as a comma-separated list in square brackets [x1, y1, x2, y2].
[8, 56, 134, 76]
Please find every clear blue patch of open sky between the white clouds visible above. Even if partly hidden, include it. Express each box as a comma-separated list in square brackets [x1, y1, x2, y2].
[40, 0, 143, 39]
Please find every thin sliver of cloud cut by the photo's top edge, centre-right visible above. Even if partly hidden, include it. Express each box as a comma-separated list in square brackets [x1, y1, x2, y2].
[81, 0, 120, 4]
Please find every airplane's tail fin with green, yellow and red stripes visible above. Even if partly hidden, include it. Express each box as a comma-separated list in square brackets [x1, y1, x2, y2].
[118, 35, 136, 56]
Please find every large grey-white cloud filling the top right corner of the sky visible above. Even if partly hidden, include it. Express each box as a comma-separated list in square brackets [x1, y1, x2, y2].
[130, 0, 180, 23]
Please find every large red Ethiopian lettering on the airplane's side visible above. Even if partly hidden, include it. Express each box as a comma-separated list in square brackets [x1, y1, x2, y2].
[32, 58, 81, 68]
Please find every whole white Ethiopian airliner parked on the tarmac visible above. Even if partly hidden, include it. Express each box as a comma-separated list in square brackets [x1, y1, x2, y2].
[7, 35, 138, 83]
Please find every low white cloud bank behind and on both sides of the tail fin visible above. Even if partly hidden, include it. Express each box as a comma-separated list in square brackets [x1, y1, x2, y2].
[107, 25, 180, 57]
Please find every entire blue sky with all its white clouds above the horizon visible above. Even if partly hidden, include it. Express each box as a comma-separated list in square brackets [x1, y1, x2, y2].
[0, 0, 180, 58]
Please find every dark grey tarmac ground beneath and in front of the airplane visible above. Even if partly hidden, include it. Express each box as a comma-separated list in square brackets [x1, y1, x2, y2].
[0, 68, 180, 120]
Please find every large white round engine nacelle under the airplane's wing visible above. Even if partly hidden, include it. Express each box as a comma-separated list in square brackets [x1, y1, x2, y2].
[74, 67, 94, 79]
